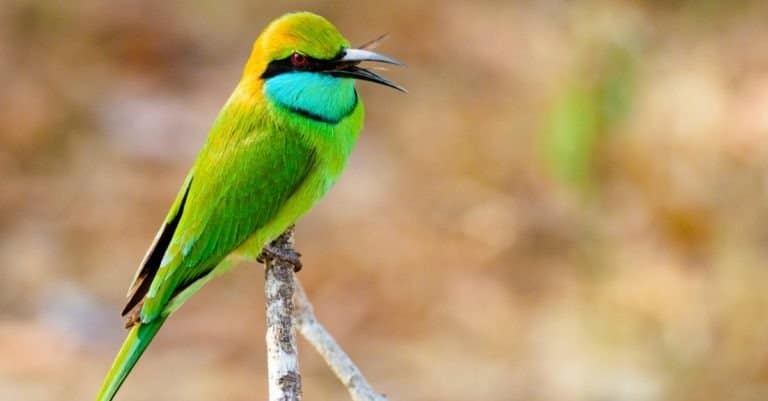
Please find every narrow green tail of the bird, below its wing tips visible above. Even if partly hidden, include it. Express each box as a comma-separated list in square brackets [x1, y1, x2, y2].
[96, 316, 166, 401]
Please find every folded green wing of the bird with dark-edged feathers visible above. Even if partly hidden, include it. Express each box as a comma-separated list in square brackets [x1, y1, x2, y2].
[124, 123, 315, 322]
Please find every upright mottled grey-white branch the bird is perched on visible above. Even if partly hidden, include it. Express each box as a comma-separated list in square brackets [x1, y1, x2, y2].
[262, 227, 301, 401]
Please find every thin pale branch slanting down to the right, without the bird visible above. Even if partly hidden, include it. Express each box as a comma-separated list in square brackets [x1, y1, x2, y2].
[294, 280, 387, 401]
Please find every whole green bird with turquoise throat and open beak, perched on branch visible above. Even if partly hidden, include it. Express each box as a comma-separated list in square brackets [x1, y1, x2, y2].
[96, 12, 406, 401]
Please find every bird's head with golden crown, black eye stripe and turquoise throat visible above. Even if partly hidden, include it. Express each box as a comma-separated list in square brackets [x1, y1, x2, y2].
[244, 12, 405, 121]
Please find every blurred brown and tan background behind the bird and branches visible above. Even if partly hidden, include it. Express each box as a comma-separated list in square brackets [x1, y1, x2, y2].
[0, 0, 768, 401]
